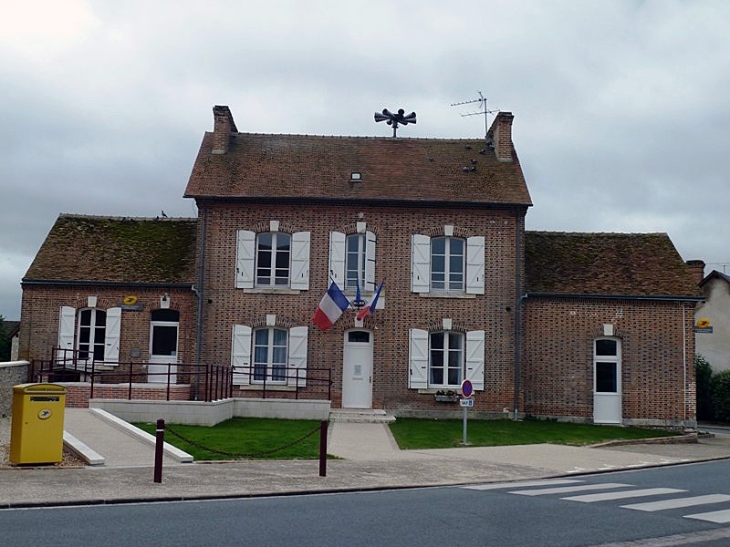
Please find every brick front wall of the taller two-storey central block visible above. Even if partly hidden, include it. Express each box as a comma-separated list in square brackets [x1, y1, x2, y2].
[199, 203, 523, 412]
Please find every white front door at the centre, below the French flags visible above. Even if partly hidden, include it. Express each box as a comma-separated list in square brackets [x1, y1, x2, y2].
[342, 330, 373, 408]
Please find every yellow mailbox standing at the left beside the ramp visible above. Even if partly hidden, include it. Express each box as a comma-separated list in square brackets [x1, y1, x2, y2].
[10, 384, 68, 464]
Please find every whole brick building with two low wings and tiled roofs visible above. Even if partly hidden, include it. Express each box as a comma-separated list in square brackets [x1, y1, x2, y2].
[15, 106, 701, 426]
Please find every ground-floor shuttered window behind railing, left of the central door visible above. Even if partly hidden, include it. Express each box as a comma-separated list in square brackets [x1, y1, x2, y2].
[231, 325, 308, 387]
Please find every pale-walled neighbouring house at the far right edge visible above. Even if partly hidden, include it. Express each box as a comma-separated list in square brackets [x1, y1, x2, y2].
[695, 270, 730, 372]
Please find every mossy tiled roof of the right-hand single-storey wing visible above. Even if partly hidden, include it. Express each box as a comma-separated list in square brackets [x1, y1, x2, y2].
[525, 232, 700, 297]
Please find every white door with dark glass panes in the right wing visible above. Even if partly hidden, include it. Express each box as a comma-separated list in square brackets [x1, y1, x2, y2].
[593, 339, 623, 424]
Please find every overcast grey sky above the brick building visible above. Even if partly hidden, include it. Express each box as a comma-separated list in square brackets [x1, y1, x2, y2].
[0, 0, 730, 320]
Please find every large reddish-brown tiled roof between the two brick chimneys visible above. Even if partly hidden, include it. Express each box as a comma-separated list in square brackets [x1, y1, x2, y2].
[185, 133, 531, 205]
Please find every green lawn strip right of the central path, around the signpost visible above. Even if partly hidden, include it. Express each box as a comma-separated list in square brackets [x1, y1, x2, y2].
[390, 418, 677, 449]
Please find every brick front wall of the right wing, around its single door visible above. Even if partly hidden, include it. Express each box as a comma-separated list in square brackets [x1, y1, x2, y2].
[522, 298, 696, 424]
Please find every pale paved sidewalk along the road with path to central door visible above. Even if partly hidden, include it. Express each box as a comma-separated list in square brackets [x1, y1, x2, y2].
[0, 422, 730, 508]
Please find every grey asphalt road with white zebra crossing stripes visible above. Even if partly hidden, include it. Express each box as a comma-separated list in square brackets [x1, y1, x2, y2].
[0, 461, 730, 547]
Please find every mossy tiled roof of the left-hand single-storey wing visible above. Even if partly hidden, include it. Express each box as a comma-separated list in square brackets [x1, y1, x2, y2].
[23, 215, 197, 283]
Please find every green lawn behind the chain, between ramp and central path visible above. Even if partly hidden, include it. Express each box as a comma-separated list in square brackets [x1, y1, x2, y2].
[134, 418, 320, 461]
